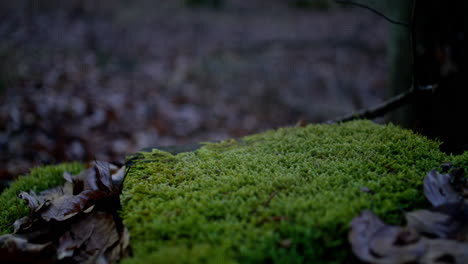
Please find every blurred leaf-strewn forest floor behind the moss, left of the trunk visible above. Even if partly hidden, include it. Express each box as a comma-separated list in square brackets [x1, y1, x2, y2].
[0, 0, 388, 180]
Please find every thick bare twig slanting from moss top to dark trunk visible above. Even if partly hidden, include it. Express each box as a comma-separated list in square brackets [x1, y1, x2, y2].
[325, 85, 437, 124]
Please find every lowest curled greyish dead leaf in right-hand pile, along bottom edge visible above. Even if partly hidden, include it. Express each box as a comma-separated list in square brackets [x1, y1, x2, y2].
[349, 211, 468, 264]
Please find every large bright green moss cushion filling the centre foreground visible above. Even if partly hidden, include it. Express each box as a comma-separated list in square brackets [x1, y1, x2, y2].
[121, 121, 458, 263]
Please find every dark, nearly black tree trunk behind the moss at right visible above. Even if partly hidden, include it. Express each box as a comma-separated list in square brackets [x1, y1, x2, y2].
[390, 0, 468, 153]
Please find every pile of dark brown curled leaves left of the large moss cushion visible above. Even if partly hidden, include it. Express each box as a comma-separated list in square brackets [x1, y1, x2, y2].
[0, 161, 130, 263]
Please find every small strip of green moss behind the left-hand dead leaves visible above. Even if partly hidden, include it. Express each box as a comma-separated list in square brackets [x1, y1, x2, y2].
[0, 163, 83, 235]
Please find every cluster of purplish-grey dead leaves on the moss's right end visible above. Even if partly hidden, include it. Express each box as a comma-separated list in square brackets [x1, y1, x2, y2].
[348, 164, 468, 264]
